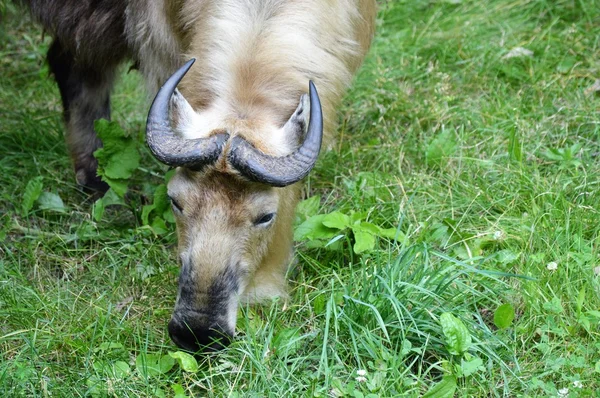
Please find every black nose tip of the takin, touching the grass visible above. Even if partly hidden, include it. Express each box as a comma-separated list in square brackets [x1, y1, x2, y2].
[169, 316, 233, 353]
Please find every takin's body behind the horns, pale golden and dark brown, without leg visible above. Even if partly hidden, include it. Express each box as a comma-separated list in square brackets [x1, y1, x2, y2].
[17, 0, 376, 166]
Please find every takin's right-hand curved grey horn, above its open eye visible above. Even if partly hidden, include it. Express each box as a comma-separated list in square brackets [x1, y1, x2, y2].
[228, 81, 323, 187]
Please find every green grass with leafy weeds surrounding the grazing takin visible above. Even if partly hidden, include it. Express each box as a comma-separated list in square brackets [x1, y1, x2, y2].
[0, 0, 600, 397]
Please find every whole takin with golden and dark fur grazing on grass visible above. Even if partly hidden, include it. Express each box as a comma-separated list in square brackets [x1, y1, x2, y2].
[17, 0, 376, 352]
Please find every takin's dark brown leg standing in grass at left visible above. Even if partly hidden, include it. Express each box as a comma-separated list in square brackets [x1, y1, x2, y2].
[48, 39, 118, 193]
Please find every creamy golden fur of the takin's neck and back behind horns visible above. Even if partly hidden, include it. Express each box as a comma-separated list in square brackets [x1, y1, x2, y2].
[127, 0, 376, 151]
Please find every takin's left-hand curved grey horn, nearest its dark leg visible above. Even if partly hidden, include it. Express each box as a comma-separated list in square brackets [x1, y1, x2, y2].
[146, 58, 229, 170]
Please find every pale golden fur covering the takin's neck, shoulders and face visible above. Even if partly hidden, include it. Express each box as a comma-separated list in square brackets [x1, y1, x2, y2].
[155, 0, 375, 328]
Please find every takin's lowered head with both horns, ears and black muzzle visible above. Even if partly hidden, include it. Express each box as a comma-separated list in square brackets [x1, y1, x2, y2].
[146, 60, 323, 352]
